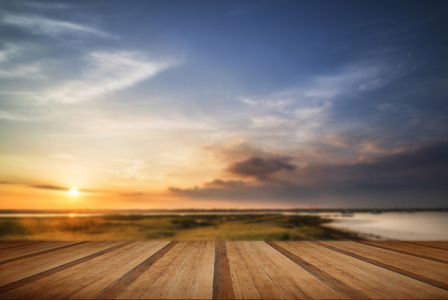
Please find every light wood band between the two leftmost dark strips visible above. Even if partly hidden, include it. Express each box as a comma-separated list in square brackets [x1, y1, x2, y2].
[0, 242, 122, 294]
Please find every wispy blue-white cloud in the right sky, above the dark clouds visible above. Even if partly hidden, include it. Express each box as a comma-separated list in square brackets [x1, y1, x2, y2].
[240, 61, 406, 144]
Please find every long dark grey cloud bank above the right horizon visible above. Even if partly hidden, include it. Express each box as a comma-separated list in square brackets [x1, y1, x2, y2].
[169, 140, 448, 208]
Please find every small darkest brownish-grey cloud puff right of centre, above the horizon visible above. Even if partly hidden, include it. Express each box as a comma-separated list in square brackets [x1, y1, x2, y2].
[227, 157, 296, 179]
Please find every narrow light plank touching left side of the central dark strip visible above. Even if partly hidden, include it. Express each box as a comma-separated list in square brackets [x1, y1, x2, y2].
[186, 242, 214, 299]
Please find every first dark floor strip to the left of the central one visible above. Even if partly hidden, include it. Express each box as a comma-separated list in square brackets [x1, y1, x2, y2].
[95, 241, 178, 299]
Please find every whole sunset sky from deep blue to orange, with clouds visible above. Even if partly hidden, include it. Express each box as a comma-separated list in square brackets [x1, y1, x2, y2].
[0, 0, 448, 210]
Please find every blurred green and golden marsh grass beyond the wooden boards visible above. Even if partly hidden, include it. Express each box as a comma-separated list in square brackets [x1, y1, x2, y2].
[0, 214, 356, 241]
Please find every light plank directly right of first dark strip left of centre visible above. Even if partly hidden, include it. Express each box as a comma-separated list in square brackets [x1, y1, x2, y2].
[115, 242, 195, 299]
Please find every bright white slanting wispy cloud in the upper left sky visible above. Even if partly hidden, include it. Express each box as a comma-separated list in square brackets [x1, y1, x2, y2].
[41, 51, 178, 103]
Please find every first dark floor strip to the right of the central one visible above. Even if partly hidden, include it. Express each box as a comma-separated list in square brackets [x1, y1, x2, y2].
[266, 241, 369, 299]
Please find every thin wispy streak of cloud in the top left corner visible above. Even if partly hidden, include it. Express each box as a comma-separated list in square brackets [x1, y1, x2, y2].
[0, 13, 114, 38]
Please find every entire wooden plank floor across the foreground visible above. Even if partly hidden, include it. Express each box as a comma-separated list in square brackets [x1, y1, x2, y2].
[0, 241, 448, 299]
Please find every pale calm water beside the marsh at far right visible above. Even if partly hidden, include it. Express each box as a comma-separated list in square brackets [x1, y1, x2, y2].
[327, 212, 448, 241]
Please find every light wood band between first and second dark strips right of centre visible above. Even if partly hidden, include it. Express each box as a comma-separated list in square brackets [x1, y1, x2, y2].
[279, 242, 448, 299]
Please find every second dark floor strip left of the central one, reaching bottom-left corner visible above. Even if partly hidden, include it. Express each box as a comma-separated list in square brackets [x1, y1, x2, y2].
[0, 242, 129, 294]
